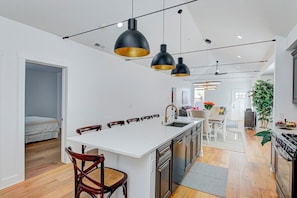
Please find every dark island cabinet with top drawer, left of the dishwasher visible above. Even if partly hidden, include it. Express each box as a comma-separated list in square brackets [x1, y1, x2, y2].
[156, 141, 172, 198]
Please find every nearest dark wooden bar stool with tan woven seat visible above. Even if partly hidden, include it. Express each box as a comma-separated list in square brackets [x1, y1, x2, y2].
[65, 147, 128, 198]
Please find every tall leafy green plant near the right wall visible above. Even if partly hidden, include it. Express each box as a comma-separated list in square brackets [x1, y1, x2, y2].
[250, 80, 273, 145]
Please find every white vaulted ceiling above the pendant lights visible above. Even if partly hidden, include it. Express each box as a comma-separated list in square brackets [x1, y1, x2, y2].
[0, 0, 297, 82]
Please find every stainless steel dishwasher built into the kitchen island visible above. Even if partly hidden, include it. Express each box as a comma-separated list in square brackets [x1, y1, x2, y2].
[172, 134, 186, 191]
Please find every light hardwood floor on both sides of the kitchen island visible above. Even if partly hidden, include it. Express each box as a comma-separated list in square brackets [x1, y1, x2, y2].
[0, 130, 277, 198]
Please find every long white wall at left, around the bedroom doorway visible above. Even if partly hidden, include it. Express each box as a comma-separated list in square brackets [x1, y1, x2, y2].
[0, 15, 191, 189]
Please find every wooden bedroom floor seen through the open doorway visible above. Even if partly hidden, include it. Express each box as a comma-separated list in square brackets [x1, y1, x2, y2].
[25, 135, 63, 179]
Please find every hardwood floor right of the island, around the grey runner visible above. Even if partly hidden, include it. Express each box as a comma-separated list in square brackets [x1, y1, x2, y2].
[170, 130, 277, 198]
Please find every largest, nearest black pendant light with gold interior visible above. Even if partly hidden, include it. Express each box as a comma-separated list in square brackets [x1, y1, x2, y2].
[114, 0, 150, 57]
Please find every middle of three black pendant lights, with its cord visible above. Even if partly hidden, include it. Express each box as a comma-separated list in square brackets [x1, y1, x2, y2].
[151, 0, 175, 70]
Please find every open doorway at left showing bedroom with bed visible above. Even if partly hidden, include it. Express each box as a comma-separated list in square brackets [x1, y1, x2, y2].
[25, 61, 63, 179]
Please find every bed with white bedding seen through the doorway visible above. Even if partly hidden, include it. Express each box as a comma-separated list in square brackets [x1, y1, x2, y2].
[25, 116, 60, 144]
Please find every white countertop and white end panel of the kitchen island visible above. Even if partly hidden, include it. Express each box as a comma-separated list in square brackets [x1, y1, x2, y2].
[68, 117, 202, 198]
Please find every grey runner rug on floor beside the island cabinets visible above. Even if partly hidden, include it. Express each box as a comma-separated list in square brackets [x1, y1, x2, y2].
[180, 162, 228, 197]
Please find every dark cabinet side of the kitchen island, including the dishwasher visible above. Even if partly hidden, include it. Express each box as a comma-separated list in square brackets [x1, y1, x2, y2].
[156, 122, 201, 195]
